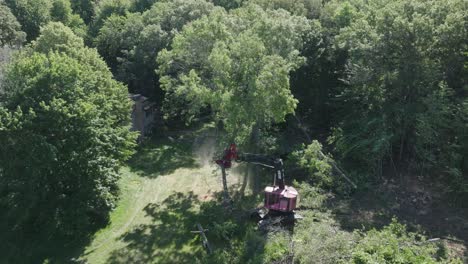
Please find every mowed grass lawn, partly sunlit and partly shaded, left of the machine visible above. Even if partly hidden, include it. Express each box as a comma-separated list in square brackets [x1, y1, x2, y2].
[78, 130, 240, 263]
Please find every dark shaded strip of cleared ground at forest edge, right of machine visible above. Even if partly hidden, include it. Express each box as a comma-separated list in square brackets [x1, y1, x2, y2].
[329, 182, 468, 245]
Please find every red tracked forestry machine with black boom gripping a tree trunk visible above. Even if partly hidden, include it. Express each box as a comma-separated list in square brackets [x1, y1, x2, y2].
[216, 144, 298, 222]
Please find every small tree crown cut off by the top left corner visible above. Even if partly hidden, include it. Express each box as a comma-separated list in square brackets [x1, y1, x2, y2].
[0, 1, 26, 47]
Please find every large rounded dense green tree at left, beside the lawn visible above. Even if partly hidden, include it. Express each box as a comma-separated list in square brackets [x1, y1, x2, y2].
[0, 23, 135, 235]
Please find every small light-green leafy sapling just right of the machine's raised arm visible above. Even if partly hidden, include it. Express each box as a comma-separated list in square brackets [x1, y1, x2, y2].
[292, 140, 333, 187]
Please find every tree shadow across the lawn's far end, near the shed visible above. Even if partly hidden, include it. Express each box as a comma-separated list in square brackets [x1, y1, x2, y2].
[128, 136, 198, 178]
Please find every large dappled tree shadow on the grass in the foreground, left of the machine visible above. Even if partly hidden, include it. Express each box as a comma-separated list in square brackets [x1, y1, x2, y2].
[107, 192, 264, 264]
